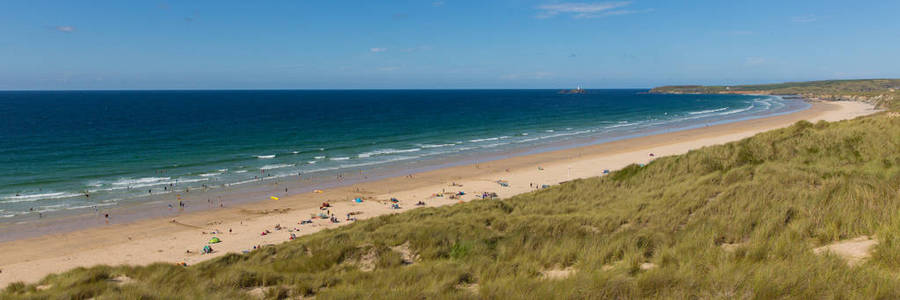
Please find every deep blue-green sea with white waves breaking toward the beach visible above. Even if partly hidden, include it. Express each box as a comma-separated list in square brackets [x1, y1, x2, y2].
[0, 89, 809, 222]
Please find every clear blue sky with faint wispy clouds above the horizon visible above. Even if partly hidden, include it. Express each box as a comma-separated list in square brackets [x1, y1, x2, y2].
[0, 0, 900, 90]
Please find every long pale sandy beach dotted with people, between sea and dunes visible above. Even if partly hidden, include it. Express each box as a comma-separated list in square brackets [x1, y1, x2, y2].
[0, 102, 877, 286]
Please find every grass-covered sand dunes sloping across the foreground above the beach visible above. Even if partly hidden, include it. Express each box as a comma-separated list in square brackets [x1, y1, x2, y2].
[0, 113, 900, 299]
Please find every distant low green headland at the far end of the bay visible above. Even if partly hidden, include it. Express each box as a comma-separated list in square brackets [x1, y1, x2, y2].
[650, 79, 900, 109]
